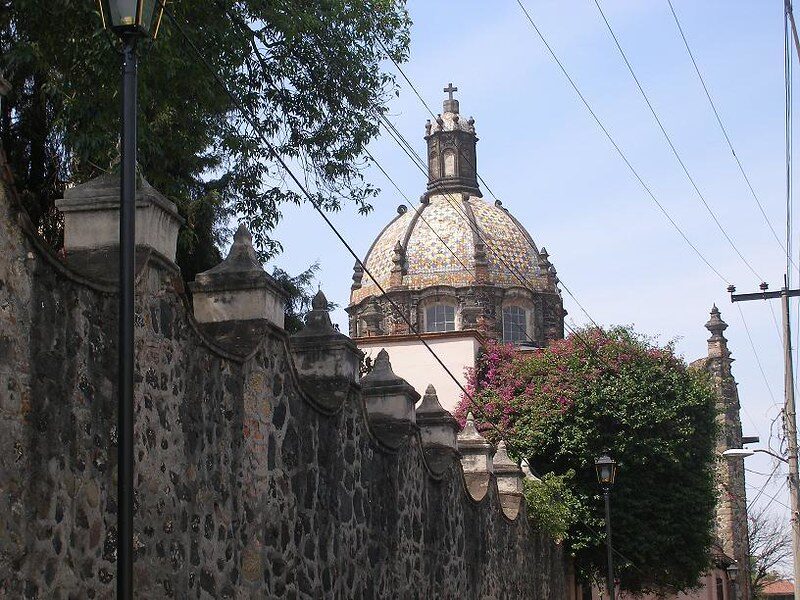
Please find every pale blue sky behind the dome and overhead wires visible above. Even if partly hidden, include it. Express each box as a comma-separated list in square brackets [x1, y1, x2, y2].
[276, 0, 800, 536]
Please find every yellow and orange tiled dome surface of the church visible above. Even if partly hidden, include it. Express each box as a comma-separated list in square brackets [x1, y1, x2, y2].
[350, 193, 552, 305]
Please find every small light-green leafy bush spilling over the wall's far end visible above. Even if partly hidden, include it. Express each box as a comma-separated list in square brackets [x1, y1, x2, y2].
[523, 471, 579, 541]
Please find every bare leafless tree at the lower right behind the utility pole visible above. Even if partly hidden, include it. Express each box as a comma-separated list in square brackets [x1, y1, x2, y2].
[747, 510, 792, 598]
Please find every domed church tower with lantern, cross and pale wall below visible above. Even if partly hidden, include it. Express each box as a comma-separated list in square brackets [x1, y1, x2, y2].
[347, 84, 564, 410]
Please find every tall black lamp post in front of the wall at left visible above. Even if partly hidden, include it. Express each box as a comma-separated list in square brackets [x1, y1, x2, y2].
[94, 0, 163, 600]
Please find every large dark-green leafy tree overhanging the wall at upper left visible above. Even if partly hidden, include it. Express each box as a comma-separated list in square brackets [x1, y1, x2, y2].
[0, 0, 409, 279]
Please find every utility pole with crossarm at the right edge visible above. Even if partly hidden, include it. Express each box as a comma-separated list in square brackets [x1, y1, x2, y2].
[728, 278, 800, 600]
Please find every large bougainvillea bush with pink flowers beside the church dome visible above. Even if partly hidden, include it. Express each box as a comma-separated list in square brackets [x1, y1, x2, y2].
[456, 327, 716, 593]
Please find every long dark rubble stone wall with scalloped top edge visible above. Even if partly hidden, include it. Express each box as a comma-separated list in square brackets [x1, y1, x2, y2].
[0, 175, 568, 600]
